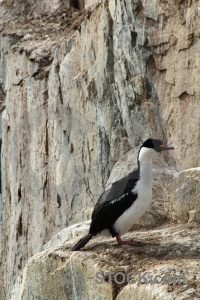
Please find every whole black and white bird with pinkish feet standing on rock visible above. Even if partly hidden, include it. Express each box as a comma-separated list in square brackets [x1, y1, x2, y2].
[72, 139, 174, 251]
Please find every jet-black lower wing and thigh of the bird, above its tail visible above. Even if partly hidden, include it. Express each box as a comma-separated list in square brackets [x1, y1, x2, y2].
[89, 192, 137, 236]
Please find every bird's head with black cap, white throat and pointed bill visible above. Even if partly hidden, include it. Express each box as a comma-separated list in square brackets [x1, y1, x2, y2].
[138, 139, 174, 160]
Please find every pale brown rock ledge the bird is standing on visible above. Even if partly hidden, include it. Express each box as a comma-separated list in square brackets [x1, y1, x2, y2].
[12, 223, 200, 300]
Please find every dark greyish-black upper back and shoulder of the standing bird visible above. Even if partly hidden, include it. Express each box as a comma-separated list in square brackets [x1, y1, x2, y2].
[92, 170, 139, 219]
